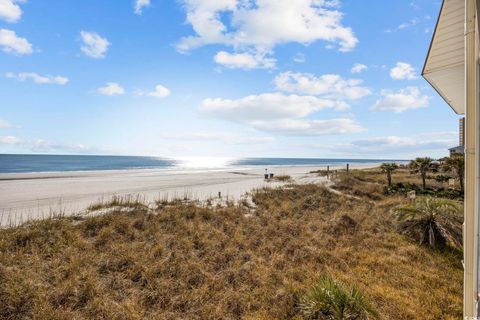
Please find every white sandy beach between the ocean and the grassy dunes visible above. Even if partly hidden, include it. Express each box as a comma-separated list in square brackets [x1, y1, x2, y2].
[0, 164, 376, 226]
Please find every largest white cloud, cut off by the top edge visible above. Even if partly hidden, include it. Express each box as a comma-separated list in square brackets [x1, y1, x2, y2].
[176, 0, 358, 63]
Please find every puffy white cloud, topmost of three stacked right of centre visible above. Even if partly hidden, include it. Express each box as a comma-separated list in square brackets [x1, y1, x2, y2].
[274, 72, 371, 100]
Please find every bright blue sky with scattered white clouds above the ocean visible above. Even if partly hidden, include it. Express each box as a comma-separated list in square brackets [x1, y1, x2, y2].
[0, 0, 458, 159]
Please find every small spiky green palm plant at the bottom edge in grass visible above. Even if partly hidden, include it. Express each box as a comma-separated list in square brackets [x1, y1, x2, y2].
[300, 276, 378, 320]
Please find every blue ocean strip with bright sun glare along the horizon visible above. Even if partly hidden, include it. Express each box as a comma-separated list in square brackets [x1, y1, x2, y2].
[0, 154, 403, 173]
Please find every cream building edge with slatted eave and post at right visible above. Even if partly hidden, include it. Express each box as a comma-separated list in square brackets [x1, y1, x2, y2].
[422, 0, 480, 320]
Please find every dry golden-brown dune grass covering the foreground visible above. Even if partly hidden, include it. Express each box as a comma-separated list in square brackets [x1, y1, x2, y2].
[0, 174, 463, 320]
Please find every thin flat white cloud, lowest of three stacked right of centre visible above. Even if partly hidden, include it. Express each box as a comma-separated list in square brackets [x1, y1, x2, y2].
[253, 118, 366, 136]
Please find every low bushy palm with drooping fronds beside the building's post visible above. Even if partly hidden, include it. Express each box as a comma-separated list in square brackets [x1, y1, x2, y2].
[394, 198, 463, 248]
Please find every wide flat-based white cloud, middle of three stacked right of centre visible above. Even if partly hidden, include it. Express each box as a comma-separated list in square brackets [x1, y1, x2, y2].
[200, 93, 344, 123]
